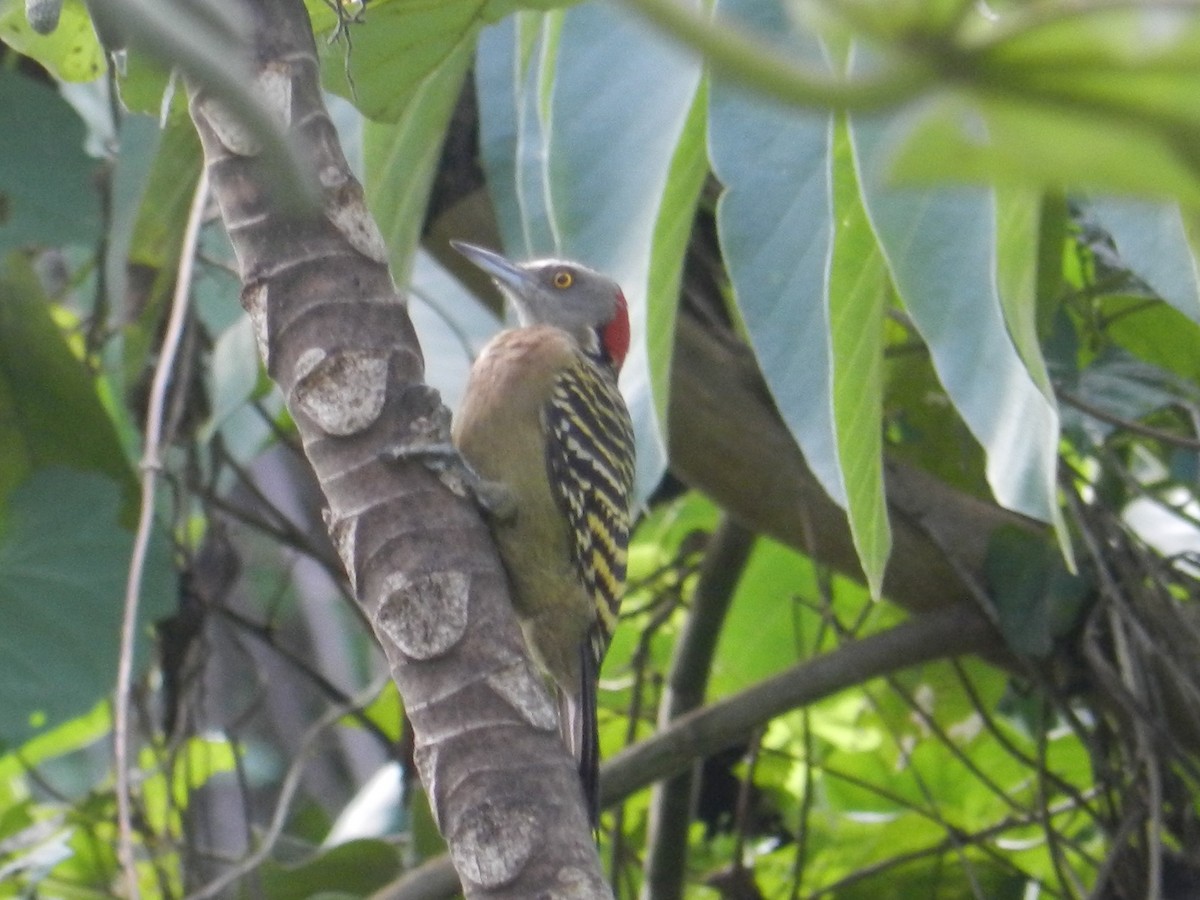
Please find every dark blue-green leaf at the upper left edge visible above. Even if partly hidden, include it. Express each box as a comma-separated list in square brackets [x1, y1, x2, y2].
[0, 68, 100, 254]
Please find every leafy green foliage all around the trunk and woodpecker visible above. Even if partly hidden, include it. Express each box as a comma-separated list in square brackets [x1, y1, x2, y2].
[0, 0, 1200, 898]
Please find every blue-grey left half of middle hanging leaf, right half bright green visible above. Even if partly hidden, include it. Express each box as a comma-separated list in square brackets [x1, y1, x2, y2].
[708, 0, 846, 506]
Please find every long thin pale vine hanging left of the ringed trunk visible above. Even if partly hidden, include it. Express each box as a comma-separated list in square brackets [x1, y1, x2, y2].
[113, 169, 209, 900]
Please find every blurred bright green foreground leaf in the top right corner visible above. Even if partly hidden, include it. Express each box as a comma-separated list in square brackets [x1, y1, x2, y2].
[894, 4, 1200, 206]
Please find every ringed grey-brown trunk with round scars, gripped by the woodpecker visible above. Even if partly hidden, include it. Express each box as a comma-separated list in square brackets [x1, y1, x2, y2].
[170, 0, 611, 900]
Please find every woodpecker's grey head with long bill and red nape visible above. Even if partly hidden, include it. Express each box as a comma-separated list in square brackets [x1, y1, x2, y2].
[450, 241, 629, 370]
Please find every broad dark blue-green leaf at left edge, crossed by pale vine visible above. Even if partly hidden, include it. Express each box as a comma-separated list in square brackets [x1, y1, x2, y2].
[0, 467, 178, 744]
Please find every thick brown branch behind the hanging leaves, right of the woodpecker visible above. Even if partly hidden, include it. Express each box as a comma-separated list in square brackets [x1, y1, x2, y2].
[667, 307, 1044, 612]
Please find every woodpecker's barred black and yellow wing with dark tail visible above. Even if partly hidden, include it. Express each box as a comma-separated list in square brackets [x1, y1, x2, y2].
[545, 354, 634, 822]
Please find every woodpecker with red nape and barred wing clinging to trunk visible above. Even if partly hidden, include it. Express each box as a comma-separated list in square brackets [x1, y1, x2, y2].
[451, 241, 634, 824]
